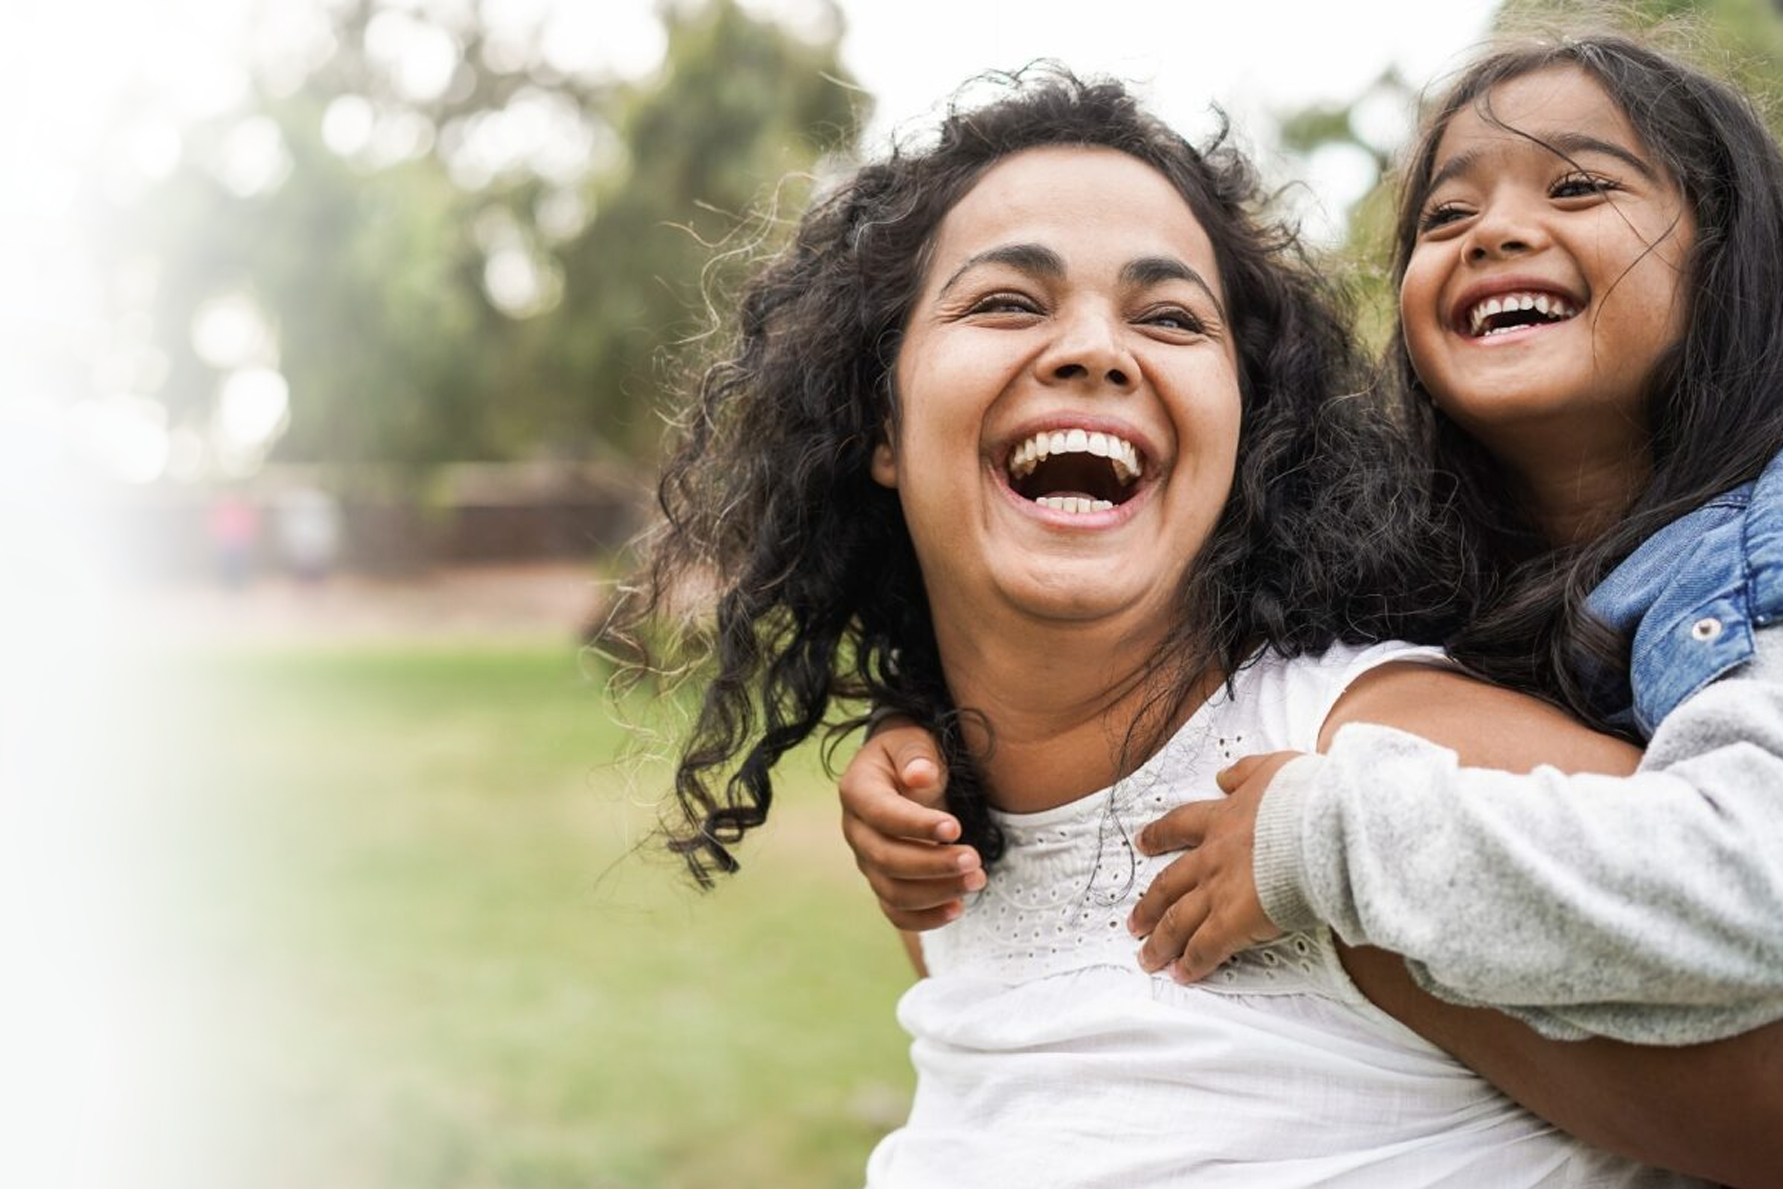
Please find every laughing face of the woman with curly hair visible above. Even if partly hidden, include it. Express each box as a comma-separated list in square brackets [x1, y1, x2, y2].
[874, 146, 1241, 645]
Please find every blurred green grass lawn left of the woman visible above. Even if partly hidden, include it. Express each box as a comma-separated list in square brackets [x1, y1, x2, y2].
[159, 647, 909, 1189]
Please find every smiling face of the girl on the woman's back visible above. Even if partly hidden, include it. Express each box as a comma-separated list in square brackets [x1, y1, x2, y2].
[1400, 66, 1694, 462]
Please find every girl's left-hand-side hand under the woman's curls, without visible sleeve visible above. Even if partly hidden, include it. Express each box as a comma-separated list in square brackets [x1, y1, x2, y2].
[840, 718, 984, 932]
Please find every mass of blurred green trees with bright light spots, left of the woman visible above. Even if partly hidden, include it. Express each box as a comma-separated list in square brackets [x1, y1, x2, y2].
[112, 0, 868, 492]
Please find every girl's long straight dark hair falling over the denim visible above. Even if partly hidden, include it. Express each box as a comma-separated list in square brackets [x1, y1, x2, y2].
[1387, 36, 1783, 726]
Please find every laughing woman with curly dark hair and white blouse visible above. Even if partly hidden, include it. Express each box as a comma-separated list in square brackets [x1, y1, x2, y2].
[647, 67, 1747, 1185]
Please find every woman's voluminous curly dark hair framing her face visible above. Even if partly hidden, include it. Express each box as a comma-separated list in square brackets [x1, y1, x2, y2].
[622, 66, 1467, 886]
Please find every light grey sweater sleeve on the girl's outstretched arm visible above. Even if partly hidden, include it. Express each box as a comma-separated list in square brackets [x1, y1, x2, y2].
[1255, 627, 1783, 1045]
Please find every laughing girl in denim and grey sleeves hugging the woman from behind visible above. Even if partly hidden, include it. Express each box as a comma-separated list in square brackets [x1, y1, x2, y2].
[845, 37, 1783, 1180]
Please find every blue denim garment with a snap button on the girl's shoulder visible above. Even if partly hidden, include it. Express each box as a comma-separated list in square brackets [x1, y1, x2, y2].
[1587, 455, 1783, 738]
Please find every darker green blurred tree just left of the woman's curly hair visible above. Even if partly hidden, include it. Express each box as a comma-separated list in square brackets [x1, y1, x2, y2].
[528, 0, 867, 453]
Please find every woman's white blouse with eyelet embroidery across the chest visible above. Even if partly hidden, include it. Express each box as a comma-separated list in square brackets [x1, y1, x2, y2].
[867, 644, 1701, 1189]
